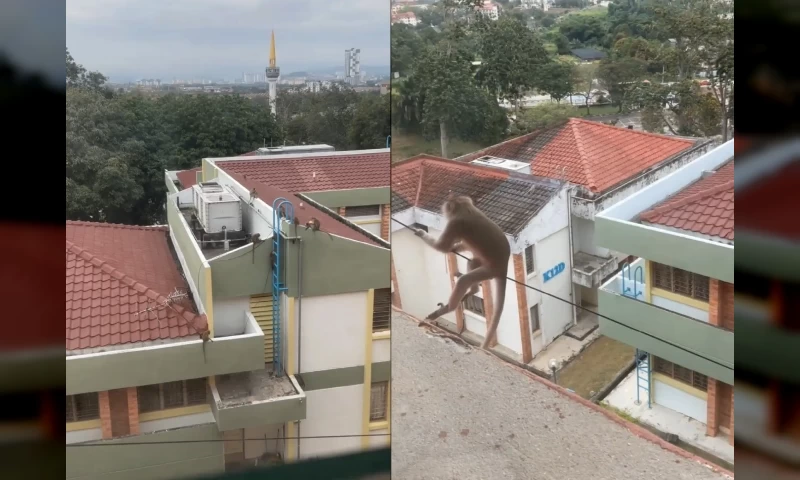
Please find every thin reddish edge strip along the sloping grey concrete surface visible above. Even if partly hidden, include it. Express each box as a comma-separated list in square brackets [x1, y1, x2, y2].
[392, 307, 734, 478]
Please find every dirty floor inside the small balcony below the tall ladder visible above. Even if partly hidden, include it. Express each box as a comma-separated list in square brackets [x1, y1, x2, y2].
[216, 368, 297, 408]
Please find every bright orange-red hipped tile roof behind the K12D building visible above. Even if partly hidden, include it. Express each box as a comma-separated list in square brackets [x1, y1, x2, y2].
[456, 118, 695, 193]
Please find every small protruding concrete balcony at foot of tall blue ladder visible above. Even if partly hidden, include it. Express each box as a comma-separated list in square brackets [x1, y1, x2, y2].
[211, 367, 306, 431]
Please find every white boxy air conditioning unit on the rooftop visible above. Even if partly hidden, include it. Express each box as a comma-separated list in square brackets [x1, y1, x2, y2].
[192, 182, 242, 233]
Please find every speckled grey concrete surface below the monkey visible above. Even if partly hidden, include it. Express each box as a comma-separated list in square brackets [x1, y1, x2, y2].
[392, 312, 729, 480]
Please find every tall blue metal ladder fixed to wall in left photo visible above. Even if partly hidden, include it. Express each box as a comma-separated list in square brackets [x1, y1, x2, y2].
[272, 197, 294, 375]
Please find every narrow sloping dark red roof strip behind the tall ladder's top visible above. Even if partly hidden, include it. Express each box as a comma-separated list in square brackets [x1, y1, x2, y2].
[228, 172, 385, 248]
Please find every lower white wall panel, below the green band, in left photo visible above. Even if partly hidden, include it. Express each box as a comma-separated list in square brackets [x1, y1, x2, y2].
[298, 384, 364, 459]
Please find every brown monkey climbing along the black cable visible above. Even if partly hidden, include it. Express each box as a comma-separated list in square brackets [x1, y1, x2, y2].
[414, 193, 511, 349]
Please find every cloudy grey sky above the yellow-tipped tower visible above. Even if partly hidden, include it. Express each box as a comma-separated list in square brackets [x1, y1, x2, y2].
[66, 0, 389, 81]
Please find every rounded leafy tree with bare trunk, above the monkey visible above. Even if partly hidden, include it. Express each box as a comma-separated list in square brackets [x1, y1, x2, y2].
[414, 42, 480, 158]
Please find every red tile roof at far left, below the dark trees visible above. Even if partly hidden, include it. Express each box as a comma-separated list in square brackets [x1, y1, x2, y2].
[66, 221, 208, 351]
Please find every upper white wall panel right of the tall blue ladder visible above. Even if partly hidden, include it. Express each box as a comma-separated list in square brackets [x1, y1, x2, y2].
[294, 292, 367, 374]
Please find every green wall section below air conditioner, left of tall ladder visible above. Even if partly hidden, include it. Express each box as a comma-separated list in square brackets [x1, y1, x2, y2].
[208, 238, 272, 299]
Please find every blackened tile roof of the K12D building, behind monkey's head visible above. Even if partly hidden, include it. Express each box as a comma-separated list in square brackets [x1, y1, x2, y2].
[392, 155, 560, 235]
